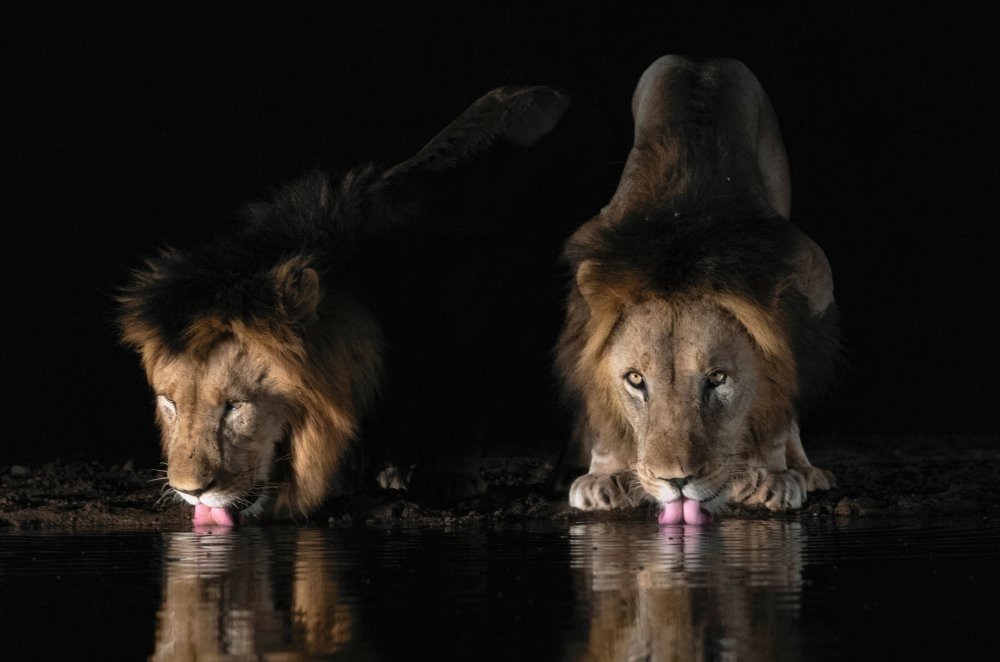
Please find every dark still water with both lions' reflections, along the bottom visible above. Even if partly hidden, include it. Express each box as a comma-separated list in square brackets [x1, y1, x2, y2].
[0, 519, 1000, 661]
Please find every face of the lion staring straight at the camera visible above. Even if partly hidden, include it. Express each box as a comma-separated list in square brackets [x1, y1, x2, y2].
[604, 299, 760, 504]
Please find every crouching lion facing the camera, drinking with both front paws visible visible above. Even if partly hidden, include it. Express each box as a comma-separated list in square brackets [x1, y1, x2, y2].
[556, 56, 839, 523]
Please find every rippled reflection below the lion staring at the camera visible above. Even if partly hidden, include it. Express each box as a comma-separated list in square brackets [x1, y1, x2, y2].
[570, 520, 802, 660]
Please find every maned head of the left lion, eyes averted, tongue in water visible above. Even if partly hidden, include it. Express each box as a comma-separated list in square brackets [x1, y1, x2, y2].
[121, 251, 381, 524]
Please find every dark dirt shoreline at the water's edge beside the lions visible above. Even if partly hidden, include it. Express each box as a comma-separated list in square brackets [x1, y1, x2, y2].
[0, 435, 1000, 530]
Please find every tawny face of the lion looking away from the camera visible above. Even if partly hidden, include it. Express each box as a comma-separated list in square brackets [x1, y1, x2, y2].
[151, 339, 291, 512]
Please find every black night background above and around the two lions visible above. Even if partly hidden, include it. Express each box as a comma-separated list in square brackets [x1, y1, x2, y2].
[0, 2, 1000, 466]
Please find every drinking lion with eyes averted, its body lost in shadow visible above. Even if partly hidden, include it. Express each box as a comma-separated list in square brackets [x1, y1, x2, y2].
[118, 86, 596, 526]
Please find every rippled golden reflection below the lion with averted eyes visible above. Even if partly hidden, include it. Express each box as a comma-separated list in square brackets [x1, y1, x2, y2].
[151, 527, 366, 660]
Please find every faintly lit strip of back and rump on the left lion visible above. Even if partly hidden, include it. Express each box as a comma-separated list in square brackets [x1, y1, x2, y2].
[384, 86, 570, 179]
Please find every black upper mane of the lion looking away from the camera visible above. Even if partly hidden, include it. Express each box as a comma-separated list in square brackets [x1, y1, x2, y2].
[118, 167, 413, 352]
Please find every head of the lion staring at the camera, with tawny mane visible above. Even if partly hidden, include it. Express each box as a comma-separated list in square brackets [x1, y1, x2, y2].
[562, 254, 798, 519]
